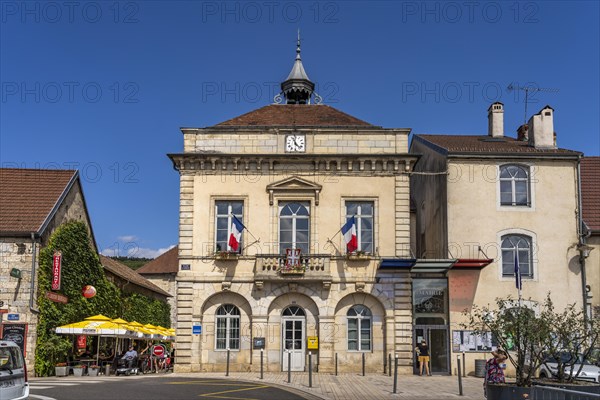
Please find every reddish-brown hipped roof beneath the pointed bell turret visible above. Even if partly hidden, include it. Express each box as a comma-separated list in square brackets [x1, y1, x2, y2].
[215, 104, 374, 127]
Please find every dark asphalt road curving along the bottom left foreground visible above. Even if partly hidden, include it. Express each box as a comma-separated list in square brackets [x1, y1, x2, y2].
[30, 374, 307, 400]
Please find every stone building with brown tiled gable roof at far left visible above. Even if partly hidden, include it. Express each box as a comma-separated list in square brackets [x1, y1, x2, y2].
[0, 168, 97, 371]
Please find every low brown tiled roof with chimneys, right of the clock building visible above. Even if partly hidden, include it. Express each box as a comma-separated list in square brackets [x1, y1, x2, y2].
[413, 135, 581, 158]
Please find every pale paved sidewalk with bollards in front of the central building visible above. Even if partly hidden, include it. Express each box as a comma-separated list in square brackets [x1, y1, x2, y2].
[171, 372, 484, 400]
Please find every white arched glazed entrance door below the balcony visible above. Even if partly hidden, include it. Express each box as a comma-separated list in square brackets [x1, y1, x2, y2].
[281, 306, 306, 371]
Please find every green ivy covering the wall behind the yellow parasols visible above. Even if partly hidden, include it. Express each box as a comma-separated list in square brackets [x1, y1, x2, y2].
[35, 221, 170, 376]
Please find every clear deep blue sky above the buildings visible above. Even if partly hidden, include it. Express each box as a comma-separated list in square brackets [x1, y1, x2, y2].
[0, 1, 600, 256]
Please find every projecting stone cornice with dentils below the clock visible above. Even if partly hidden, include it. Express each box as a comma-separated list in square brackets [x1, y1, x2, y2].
[168, 152, 419, 174]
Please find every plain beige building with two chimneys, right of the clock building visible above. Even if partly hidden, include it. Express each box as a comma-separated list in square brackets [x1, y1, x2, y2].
[410, 103, 584, 372]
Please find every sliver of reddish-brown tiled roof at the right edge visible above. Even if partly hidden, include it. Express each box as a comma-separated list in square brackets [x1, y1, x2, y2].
[581, 157, 600, 233]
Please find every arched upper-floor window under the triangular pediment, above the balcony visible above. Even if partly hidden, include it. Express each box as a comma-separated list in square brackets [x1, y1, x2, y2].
[279, 202, 310, 254]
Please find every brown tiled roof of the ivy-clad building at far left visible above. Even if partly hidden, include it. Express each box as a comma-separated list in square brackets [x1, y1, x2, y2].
[0, 168, 78, 234]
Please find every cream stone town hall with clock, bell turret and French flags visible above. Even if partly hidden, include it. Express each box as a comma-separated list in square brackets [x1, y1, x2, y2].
[169, 39, 418, 373]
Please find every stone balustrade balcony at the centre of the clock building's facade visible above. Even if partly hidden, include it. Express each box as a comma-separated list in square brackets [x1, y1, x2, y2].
[254, 254, 331, 281]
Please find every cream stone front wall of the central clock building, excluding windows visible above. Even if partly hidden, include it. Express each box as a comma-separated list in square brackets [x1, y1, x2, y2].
[171, 119, 416, 373]
